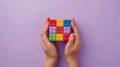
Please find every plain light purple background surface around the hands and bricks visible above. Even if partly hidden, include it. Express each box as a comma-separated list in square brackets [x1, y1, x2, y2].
[0, 0, 120, 67]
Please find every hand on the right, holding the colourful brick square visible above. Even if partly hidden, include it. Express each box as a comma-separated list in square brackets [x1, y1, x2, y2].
[65, 19, 81, 67]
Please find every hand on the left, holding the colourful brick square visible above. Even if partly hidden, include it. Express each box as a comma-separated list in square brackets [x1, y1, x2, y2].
[41, 18, 59, 67]
